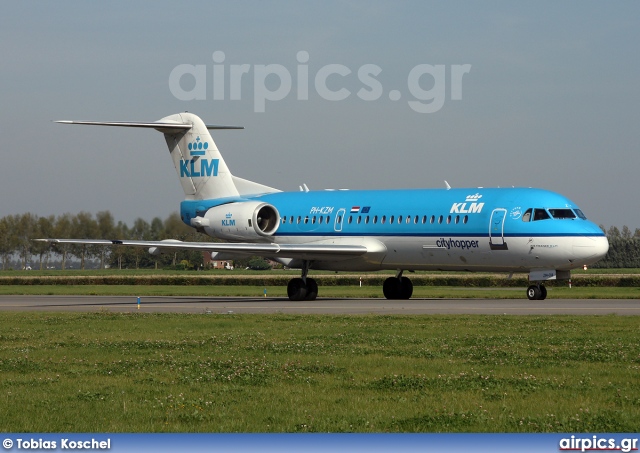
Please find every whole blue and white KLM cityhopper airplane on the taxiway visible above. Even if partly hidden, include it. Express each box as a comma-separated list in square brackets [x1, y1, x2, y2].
[41, 112, 609, 301]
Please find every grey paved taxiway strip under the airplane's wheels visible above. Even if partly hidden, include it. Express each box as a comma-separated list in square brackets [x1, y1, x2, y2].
[0, 296, 640, 315]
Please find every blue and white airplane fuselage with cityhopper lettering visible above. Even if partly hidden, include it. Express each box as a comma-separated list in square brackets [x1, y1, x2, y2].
[181, 188, 608, 272]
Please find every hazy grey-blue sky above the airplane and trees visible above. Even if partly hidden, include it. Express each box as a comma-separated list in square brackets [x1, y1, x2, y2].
[0, 0, 640, 231]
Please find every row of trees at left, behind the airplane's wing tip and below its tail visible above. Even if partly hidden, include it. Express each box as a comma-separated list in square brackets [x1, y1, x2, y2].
[0, 211, 212, 270]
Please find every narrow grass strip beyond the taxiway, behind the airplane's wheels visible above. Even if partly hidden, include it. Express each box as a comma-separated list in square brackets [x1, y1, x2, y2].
[0, 285, 640, 299]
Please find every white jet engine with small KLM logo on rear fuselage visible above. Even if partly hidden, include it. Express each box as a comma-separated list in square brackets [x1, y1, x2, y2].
[202, 201, 280, 241]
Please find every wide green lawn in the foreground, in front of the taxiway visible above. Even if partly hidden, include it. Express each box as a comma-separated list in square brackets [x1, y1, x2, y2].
[0, 312, 640, 432]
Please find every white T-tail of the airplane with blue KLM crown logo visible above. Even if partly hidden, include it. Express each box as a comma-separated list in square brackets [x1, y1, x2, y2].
[58, 112, 278, 200]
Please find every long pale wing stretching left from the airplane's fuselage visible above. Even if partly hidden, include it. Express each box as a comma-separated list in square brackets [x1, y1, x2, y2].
[34, 239, 371, 261]
